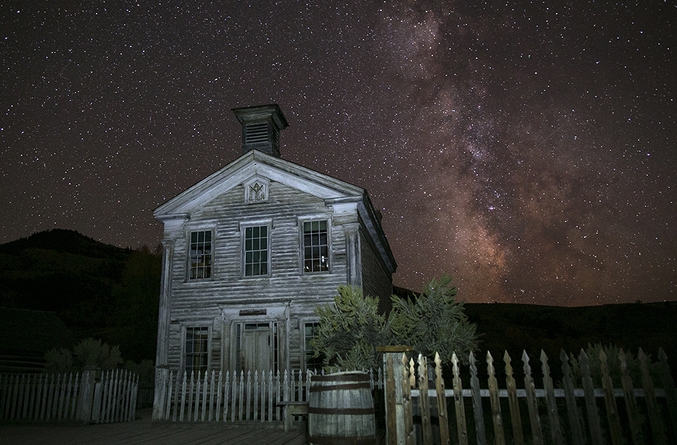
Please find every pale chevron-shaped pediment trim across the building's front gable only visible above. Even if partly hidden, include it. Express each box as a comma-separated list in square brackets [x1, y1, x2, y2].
[154, 150, 365, 220]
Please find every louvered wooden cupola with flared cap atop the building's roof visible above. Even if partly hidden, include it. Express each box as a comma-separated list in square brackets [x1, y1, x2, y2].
[233, 104, 289, 158]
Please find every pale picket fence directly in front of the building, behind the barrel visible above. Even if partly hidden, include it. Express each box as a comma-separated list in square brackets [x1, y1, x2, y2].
[154, 369, 383, 422]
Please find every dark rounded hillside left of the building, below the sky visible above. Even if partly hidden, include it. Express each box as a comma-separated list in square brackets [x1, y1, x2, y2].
[0, 230, 160, 361]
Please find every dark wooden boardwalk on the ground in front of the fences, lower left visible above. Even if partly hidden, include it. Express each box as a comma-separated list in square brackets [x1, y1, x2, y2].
[0, 410, 307, 445]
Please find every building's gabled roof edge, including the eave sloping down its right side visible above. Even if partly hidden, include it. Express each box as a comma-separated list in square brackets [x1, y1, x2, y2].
[153, 150, 397, 273]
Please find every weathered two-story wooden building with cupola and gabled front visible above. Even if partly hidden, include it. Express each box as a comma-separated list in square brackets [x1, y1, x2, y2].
[155, 105, 396, 406]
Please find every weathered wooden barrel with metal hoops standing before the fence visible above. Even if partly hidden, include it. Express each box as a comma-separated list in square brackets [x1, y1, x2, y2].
[308, 372, 376, 445]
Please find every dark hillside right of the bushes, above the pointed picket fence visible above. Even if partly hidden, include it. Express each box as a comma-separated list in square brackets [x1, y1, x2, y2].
[465, 302, 677, 380]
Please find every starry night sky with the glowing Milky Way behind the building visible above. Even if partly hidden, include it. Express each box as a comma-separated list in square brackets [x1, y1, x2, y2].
[0, 0, 677, 306]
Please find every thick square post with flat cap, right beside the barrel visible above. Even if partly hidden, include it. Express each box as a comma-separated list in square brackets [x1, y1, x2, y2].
[376, 345, 413, 445]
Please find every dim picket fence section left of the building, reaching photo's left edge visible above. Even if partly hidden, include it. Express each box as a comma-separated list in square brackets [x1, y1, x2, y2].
[0, 370, 139, 423]
